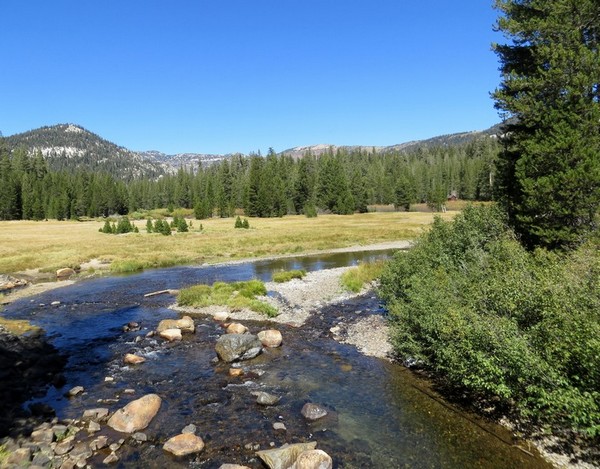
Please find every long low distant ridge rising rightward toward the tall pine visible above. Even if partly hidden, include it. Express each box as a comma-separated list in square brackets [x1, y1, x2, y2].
[281, 124, 502, 158]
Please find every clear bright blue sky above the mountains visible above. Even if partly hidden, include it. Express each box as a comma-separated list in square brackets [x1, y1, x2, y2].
[0, 0, 501, 153]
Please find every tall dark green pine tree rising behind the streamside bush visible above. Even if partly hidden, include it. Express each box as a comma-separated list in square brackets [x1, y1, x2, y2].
[494, 0, 600, 248]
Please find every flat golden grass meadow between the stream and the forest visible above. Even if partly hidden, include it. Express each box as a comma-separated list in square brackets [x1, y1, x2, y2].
[0, 208, 456, 274]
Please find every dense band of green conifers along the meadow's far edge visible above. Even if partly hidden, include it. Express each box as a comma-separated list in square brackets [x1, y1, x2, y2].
[0, 138, 499, 220]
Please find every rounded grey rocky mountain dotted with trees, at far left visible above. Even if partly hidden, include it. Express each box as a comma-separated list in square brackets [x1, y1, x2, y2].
[4, 124, 167, 180]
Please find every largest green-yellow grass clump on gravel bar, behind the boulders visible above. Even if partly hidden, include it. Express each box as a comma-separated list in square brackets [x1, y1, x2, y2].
[177, 279, 278, 317]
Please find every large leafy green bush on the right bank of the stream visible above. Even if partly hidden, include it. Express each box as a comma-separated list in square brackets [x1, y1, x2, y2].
[380, 206, 600, 437]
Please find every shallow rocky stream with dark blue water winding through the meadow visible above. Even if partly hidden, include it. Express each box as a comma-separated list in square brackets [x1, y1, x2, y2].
[4, 251, 550, 469]
